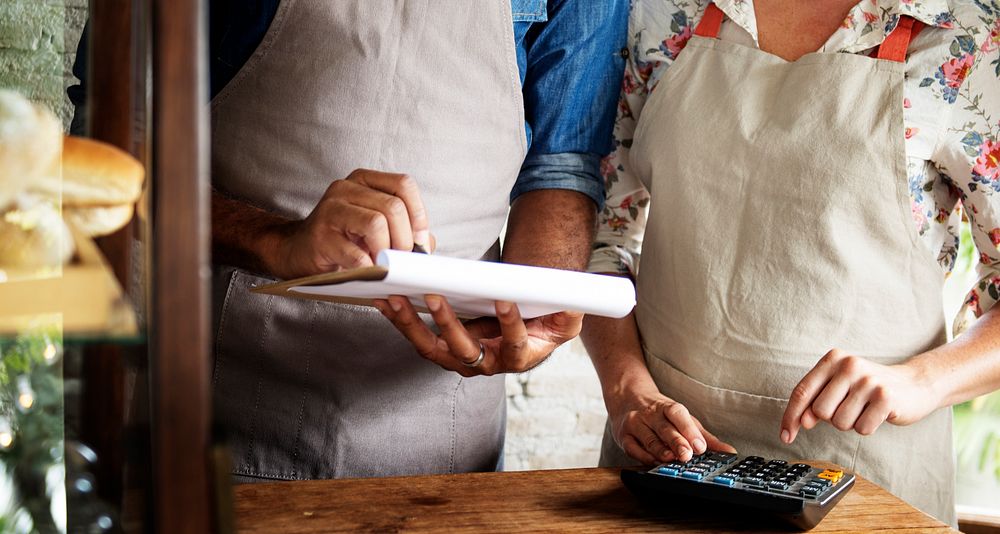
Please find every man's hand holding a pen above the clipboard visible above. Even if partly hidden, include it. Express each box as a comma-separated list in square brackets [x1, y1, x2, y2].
[267, 169, 432, 278]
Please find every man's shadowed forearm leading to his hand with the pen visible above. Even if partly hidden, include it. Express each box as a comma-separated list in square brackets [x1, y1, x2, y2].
[212, 189, 290, 276]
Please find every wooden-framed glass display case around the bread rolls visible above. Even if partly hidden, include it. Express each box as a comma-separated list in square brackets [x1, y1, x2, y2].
[0, 0, 218, 532]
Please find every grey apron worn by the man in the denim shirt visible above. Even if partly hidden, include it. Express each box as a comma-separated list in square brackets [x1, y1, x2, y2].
[212, 0, 526, 480]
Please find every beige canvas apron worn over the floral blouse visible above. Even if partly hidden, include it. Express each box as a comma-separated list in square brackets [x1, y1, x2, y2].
[602, 4, 955, 524]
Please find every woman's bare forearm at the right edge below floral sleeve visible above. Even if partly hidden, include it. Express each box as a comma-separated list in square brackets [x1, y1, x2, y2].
[907, 307, 1000, 407]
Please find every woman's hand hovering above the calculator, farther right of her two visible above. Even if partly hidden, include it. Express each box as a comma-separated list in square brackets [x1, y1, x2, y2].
[781, 349, 941, 443]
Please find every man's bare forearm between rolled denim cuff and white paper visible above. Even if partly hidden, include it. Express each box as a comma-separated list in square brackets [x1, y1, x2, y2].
[503, 189, 597, 271]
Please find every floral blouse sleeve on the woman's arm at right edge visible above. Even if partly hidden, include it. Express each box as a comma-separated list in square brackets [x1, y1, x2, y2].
[936, 23, 1000, 332]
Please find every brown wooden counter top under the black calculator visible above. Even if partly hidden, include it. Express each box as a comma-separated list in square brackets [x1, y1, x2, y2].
[234, 462, 955, 533]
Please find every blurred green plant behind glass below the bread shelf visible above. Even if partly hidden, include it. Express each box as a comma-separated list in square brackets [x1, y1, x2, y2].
[0, 316, 66, 533]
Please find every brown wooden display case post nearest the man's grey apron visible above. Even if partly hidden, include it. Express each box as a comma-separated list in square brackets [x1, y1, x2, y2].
[149, 0, 214, 534]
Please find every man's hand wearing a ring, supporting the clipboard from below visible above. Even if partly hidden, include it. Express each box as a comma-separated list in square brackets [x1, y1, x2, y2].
[375, 295, 583, 376]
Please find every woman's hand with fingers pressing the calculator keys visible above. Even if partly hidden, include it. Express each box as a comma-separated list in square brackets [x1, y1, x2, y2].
[605, 389, 736, 465]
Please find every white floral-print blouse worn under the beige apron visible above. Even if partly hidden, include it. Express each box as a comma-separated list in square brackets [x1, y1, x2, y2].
[590, 0, 1000, 331]
